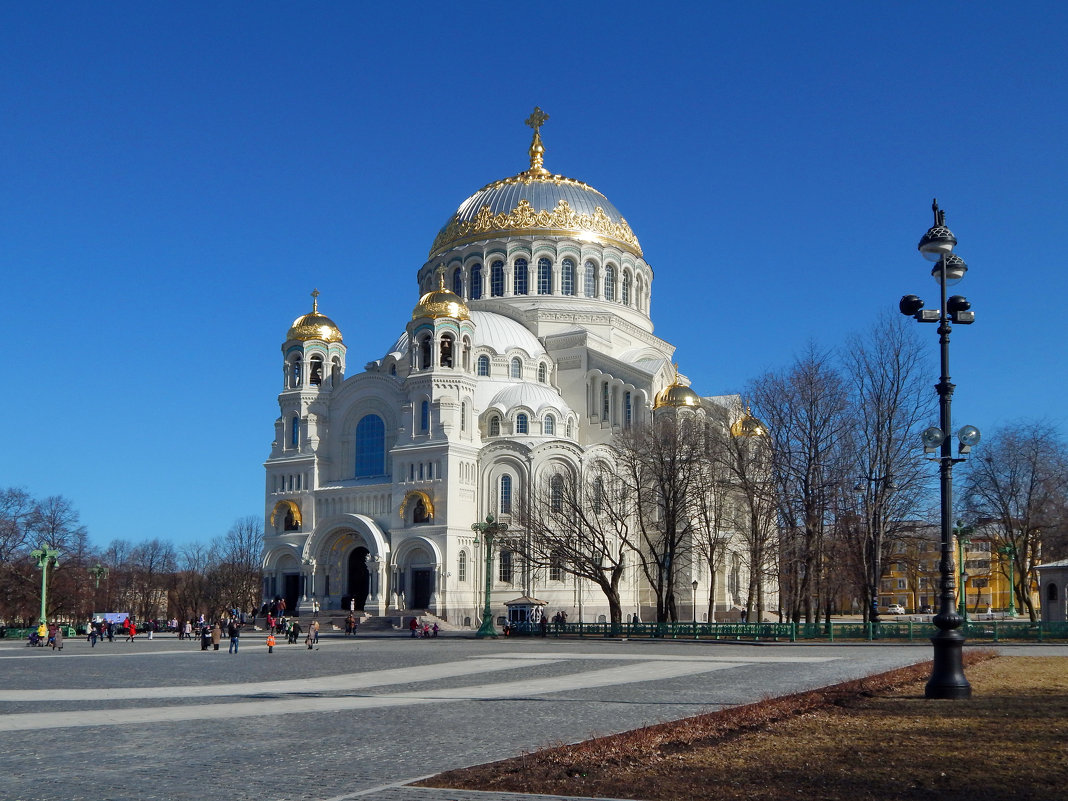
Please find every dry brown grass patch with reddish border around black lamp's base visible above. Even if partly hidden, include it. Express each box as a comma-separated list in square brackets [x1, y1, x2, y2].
[423, 651, 1068, 801]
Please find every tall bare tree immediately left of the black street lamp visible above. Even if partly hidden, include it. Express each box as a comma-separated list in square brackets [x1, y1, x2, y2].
[838, 314, 937, 617]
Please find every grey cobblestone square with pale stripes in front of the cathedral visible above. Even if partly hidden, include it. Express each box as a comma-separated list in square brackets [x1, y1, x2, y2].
[0, 634, 1050, 801]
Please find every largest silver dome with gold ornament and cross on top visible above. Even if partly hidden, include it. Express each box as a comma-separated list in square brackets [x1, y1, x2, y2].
[429, 110, 642, 258]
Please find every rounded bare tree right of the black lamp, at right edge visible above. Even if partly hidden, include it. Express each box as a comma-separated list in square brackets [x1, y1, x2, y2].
[962, 421, 1068, 621]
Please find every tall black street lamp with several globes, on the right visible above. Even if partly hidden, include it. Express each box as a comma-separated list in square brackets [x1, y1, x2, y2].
[898, 200, 979, 698]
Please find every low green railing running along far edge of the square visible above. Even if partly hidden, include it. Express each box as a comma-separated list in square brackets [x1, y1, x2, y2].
[509, 619, 1068, 643]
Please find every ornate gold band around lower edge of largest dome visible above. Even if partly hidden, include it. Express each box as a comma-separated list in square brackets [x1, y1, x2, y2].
[430, 196, 642, 257]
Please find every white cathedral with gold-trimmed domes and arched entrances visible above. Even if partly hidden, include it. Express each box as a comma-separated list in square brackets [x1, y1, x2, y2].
[263, 109, 773, 627]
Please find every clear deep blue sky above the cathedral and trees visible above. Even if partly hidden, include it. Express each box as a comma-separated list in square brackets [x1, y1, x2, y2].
[0, 2, 1068, 545]
